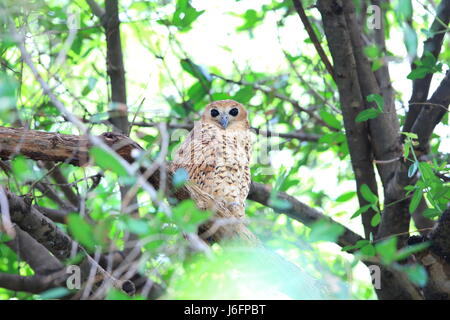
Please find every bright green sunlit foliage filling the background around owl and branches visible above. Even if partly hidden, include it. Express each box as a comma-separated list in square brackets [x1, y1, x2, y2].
[0, 0, 450, 299]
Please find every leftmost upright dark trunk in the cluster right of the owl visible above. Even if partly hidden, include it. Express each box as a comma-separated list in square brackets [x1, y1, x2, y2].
[318, 1, 378, 237]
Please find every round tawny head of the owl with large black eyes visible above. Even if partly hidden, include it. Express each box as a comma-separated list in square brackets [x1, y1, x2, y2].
[202, 100, 249, 129]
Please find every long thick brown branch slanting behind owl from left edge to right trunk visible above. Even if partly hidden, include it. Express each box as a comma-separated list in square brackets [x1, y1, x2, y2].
[0, 127, 361, 246]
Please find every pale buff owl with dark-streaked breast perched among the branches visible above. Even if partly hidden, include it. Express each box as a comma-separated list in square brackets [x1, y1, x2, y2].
[171, 100, 251, 239]
